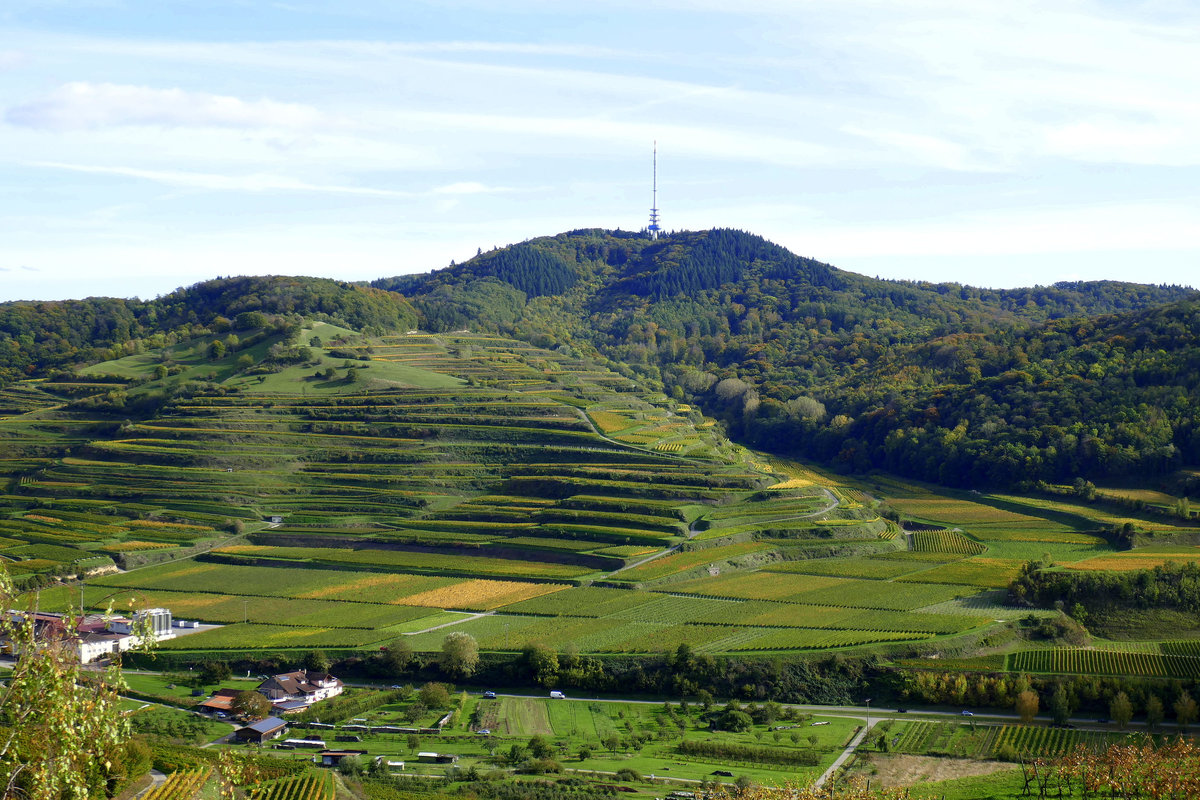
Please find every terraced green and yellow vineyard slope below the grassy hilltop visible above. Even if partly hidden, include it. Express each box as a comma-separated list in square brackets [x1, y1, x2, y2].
[0, 331, 1008, 654]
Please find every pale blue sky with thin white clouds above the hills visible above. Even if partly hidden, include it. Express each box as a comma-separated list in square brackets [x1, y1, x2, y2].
[0, 0, 1200, 301]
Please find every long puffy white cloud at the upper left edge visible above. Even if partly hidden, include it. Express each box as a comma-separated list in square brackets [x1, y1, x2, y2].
[5, 82, 324, 130]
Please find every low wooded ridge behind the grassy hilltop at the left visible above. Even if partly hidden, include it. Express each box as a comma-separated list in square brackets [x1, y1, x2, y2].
[0, 276, 418, 386]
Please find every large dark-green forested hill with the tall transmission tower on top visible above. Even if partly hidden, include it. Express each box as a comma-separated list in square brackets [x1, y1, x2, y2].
[374, 230, 1200, 486]
